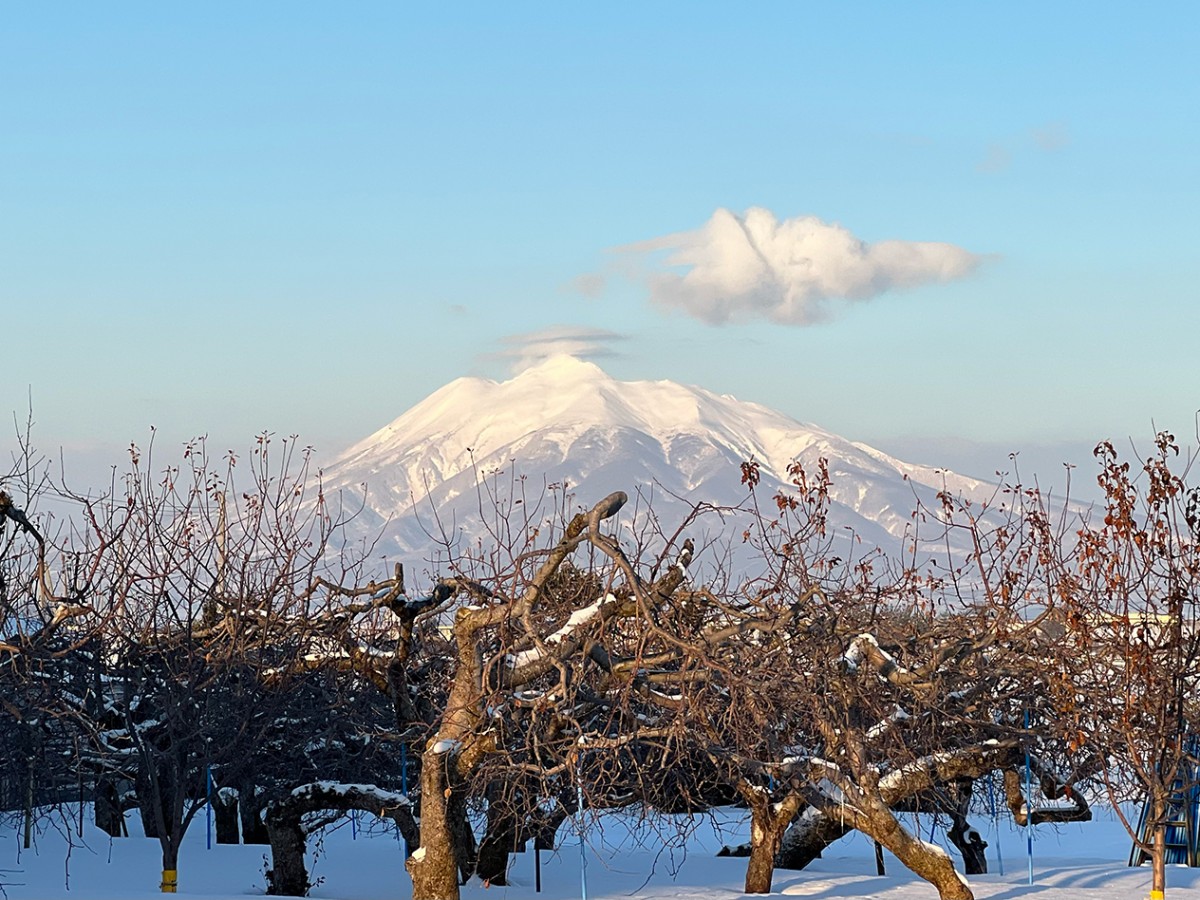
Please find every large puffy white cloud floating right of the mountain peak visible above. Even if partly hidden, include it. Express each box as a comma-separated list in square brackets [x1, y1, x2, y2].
[626, 208, 979, 325]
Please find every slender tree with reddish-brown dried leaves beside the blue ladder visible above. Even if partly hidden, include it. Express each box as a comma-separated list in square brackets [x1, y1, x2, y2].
[1045, 432, 1200, 898]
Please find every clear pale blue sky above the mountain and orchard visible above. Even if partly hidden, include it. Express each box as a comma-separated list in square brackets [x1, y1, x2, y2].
[0, 2, 1200, 494]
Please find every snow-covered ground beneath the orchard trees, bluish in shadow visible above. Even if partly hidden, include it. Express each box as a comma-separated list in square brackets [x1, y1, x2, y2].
[0, 810, 1200, 900]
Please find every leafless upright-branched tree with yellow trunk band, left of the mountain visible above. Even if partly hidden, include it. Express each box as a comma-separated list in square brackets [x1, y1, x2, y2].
[64, 434, 374, 886]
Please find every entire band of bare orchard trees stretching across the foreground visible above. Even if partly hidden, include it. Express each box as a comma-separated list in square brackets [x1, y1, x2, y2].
[0, 424, 1200, 900]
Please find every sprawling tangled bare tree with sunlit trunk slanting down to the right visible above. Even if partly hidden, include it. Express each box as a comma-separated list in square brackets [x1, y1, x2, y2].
[697, 464, 1090, 900]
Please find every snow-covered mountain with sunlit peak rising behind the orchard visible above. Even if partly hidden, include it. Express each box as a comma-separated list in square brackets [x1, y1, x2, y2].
[324, 356, 995, 566]
